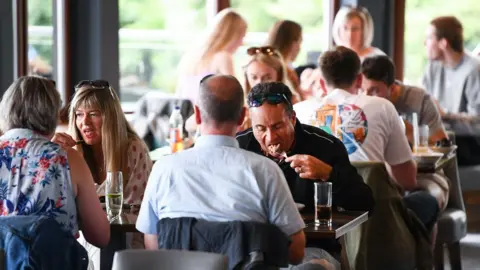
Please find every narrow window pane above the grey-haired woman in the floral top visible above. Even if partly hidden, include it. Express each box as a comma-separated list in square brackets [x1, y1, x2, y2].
[27, 0, 54, 79]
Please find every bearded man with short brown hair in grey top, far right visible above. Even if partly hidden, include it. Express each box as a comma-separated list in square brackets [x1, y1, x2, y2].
[423, 16, 480, 116]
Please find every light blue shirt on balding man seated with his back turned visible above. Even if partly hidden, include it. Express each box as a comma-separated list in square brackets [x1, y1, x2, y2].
[136, 135, 305, 235]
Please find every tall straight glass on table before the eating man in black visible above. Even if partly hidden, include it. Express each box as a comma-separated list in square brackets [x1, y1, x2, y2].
[315, 182, 332, 226]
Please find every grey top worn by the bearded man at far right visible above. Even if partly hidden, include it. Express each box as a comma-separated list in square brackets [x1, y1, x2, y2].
[423, 54, 480, 115]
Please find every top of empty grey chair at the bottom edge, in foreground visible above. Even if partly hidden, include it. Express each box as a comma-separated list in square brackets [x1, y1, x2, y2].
[112, 250, 227, 270]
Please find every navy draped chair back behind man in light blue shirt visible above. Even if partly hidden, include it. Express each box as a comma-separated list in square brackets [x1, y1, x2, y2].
[157, 217, 290, 269]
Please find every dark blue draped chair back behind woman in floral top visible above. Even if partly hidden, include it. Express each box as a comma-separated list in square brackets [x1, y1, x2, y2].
[0, 215, 88, 270]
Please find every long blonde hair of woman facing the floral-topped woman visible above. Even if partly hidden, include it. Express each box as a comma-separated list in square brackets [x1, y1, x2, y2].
[68, 85, 142, 186]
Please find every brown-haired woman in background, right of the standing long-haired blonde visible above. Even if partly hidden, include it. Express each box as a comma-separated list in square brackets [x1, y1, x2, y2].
[267, 20, 305, 100]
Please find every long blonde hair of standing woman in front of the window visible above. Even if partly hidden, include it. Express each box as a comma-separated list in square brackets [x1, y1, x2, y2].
[179, 8, 247, 75]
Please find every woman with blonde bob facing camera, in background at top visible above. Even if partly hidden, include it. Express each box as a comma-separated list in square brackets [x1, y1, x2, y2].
[332, 6, 385, 61]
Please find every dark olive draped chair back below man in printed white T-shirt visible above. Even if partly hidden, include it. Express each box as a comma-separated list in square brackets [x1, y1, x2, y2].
[345, 162, 422, 270]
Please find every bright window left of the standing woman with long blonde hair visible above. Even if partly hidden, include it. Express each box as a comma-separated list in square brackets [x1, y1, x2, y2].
[119, 0, 207, 102]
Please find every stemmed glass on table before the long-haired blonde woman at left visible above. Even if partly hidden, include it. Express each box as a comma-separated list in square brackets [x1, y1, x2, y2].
[105, 171, 123, 221]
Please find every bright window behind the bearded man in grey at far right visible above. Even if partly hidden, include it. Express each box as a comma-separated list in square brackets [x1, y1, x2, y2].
[404, 0, 480, 84]
